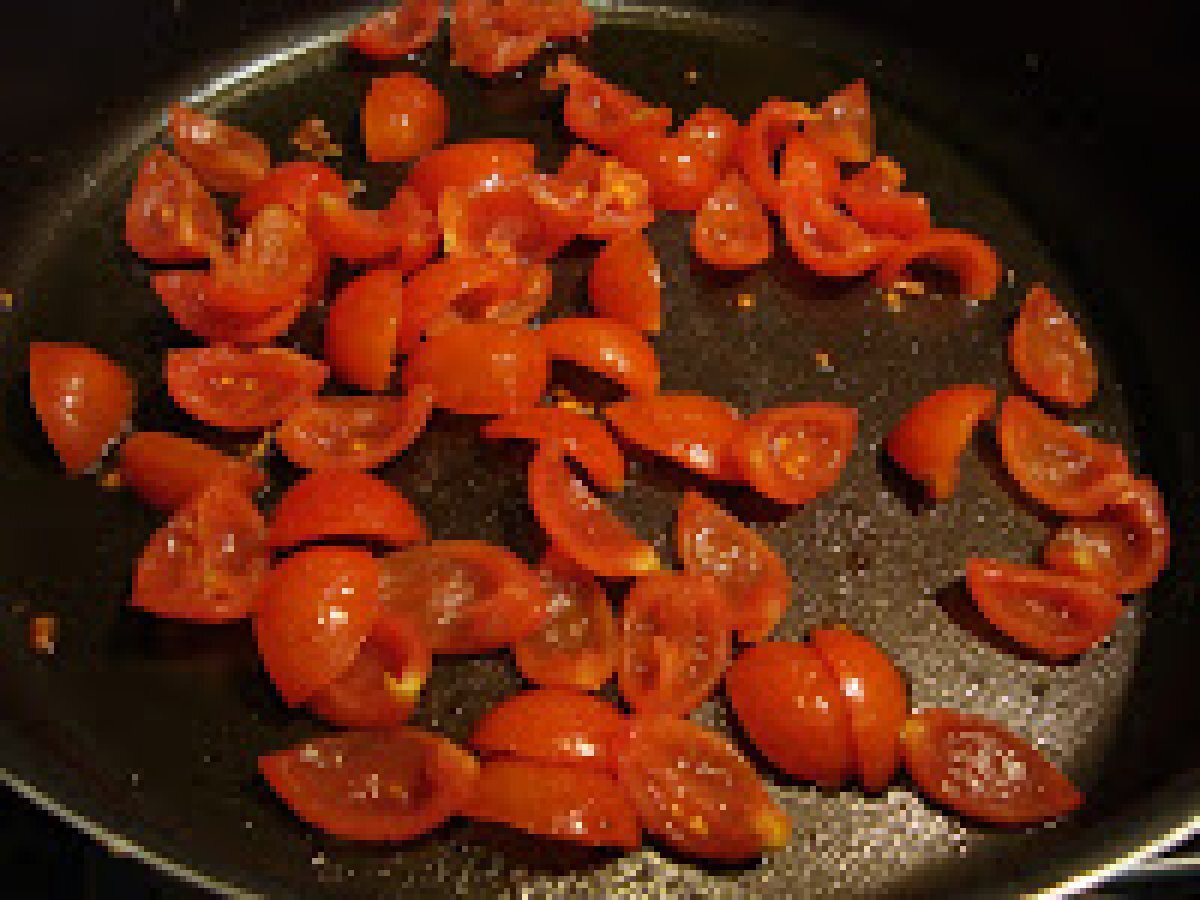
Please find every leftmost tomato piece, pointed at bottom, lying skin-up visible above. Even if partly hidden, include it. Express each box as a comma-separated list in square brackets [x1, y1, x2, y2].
[29, 341, 133, 475]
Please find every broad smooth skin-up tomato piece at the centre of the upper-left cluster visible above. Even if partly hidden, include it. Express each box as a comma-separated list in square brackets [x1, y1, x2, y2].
[404, 323, 550, 415]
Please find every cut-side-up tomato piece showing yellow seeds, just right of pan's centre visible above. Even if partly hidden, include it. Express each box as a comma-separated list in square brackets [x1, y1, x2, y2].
[733, 403, 858, 505]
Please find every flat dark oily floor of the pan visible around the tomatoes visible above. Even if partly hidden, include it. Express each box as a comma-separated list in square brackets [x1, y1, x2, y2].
[0, 7, 1185, 898]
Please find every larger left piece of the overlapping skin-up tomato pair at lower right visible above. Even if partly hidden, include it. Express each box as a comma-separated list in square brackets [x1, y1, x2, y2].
[725, 642, 854, 787]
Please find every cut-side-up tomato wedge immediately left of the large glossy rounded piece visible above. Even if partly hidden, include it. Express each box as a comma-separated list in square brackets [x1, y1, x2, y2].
[130, 480, 270, 623]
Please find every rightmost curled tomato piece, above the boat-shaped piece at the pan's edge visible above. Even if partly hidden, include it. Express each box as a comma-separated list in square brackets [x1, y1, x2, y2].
[1042, 478, 1171, 594]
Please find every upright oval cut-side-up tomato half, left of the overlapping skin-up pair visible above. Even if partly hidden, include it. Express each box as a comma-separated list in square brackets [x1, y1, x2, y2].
[617, 572, 733, 715]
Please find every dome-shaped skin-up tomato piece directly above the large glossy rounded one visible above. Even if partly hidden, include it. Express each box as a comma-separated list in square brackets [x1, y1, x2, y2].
[268, 469, 425, 550]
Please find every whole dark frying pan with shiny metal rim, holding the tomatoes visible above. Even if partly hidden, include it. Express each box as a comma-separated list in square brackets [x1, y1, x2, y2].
[0, 0, 1200, 898]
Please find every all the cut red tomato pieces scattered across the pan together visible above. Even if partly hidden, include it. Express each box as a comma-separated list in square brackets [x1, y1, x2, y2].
[29, 0, 1169, 862]
